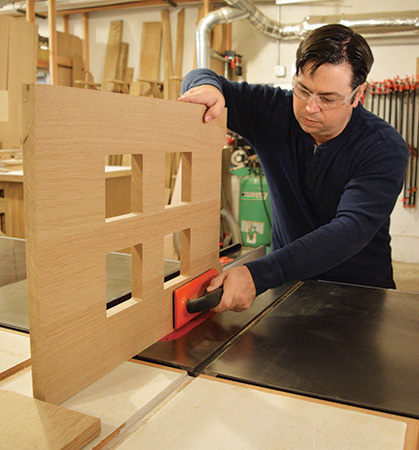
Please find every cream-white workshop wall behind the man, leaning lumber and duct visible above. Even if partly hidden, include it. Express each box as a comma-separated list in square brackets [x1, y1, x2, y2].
[37, 0, 419, 263]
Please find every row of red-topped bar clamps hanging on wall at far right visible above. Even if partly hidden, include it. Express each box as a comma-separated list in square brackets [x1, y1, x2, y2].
[369, 76, 419, 208]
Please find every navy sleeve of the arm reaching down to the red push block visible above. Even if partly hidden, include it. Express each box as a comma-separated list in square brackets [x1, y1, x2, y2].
[246, 130, 408, 294]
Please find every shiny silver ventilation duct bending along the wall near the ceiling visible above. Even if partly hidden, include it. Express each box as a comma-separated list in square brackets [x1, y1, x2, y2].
[196, 0, 419, 68]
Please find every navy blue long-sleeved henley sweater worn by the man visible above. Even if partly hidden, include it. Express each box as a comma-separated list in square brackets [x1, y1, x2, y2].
[182, 69, 408, 294]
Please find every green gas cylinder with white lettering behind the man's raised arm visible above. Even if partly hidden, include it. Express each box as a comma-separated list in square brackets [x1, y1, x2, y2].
[239, 168, 272, 247]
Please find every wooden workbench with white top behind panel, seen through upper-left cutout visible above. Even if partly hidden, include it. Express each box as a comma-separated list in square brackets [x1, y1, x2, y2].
[0, 166, 131, 239]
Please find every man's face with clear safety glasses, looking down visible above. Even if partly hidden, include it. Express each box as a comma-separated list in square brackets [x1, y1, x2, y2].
[294, 64, 366, 145]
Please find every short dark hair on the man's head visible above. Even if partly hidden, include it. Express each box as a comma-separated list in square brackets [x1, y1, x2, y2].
[296, 24, 374, 89]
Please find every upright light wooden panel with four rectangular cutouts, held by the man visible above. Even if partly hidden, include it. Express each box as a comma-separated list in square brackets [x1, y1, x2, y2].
[24, 85, 226, 403]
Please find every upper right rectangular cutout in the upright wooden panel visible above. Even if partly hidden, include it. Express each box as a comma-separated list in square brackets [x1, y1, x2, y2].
[165, 152, 192, 206]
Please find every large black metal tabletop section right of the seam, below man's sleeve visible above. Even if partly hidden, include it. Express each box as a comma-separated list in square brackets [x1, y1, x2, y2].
[204, 281, 419, 418]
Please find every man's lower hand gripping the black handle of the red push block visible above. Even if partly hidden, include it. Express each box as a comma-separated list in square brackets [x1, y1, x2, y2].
[207, 266, 256, 312]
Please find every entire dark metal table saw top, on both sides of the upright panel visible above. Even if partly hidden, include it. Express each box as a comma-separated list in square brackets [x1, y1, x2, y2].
[0, 238, 419, 446]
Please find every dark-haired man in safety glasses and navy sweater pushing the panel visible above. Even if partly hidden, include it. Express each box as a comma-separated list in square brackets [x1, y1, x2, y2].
[179, 25, 408, 312]
